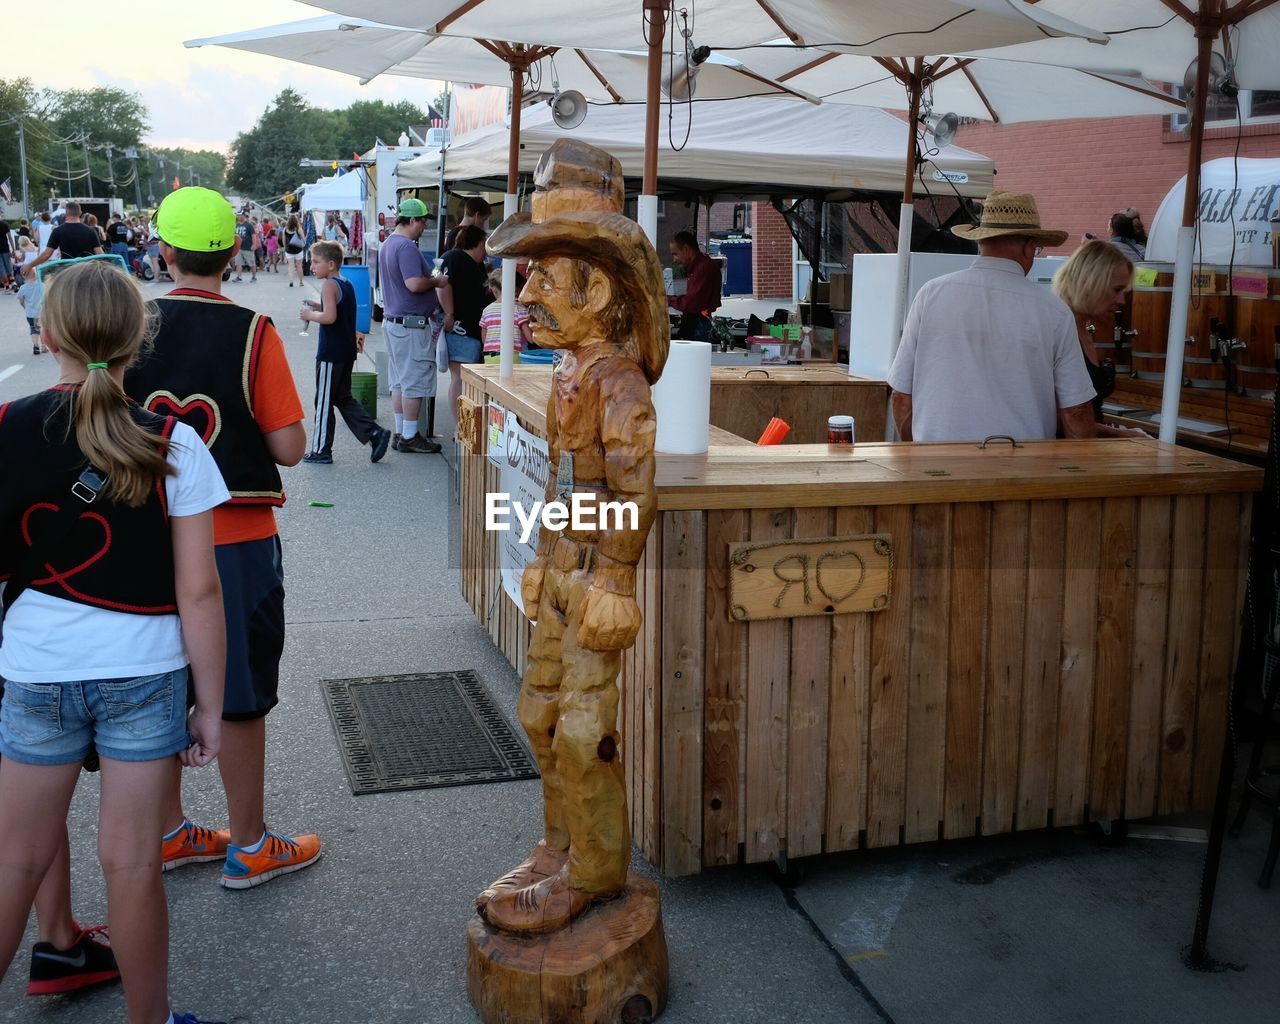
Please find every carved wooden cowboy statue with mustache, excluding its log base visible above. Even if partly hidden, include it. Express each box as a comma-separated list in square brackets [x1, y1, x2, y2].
[476, 140, 669, 934]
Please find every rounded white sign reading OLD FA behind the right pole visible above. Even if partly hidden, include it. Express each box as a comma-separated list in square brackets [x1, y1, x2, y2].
[1147, 157, 1280, 266]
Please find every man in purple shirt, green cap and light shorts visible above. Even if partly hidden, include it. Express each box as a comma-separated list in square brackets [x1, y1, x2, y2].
[378, 200, 453, 454]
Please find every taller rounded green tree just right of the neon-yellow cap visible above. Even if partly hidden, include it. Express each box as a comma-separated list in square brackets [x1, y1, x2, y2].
[227, 88, 342, 201]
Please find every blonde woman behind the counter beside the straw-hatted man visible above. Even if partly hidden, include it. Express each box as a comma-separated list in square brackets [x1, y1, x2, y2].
[1053, 238, 1147, 436]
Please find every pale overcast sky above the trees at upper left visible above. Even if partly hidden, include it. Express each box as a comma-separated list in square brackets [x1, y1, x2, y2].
[8, 0, 440, 151]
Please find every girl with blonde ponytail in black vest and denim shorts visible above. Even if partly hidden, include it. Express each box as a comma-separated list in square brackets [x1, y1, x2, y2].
[0, 260, 229, 1024]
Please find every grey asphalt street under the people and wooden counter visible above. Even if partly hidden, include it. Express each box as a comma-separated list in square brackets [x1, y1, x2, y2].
[0, 267, 1280, 1024]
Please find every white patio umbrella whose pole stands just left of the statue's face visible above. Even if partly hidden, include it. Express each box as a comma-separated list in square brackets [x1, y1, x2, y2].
[186, 14, 808, 376]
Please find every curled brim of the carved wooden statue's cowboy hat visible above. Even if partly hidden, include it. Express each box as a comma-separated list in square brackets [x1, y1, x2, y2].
[488, 217, 671, 384]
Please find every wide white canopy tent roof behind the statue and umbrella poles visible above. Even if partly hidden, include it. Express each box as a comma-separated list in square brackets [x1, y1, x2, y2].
[396, 99, 995, 200]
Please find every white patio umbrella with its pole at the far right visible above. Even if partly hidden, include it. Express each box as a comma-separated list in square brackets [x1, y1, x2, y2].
[967, 0, 1280, 444]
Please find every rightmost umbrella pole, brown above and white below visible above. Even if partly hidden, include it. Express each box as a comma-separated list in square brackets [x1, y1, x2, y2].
[1160, 18, 1216, 444]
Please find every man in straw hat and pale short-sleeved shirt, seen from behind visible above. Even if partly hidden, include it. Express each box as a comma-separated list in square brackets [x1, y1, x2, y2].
[888, 192, 1094, 442]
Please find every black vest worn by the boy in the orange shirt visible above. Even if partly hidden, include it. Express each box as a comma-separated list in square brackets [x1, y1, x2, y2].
[124, 288, 284, 506]
